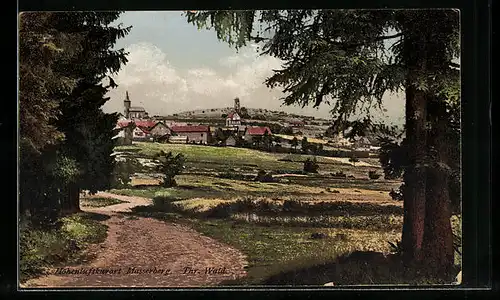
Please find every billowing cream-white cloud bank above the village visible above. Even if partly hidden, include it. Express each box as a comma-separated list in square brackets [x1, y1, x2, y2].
[103, 42, 404, 122]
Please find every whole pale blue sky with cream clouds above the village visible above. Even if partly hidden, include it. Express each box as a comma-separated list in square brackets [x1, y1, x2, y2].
[103, 11, 404, 125]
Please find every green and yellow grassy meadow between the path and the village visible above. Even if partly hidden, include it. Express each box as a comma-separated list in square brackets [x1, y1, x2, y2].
[111, 143, 459, 285]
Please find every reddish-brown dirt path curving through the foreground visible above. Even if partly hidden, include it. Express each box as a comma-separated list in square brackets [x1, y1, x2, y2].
[22, 193, 247, 288]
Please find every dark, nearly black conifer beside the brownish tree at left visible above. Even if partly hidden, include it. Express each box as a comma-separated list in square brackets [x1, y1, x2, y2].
[55, 12, 131, 212]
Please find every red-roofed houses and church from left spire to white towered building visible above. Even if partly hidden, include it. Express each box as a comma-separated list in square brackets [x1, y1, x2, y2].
[115, 92, 272, 146]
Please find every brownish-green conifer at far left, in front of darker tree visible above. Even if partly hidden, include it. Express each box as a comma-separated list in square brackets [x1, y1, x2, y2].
[19, 12, 76, 217]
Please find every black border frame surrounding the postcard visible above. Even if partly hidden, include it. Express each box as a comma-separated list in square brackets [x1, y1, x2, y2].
[0, 0, 498, 298]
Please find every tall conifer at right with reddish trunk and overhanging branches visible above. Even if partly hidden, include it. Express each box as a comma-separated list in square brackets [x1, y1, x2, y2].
[187, 10, 460, 273]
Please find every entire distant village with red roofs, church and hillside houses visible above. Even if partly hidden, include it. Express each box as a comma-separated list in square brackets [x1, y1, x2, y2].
[115, 91, 380, 158]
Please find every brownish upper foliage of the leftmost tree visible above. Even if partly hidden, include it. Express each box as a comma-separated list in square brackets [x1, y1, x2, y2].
[19, 12, 76, 152]
